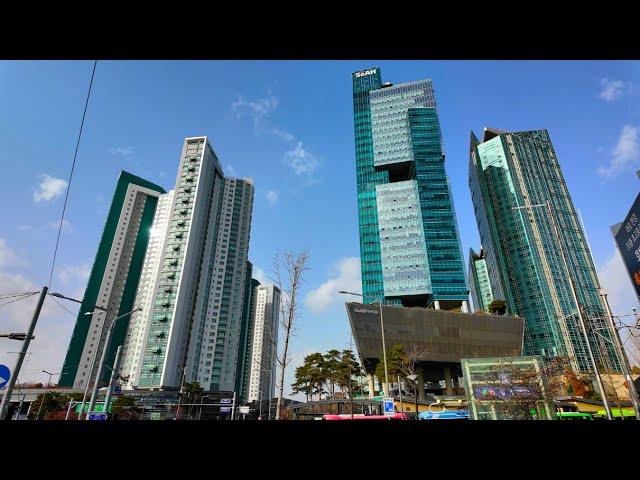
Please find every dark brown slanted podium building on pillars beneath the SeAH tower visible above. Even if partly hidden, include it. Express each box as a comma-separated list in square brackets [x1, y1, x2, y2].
[346, 302, 524, 400]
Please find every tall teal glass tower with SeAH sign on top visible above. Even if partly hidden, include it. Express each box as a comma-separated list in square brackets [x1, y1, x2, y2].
[352, 68, 469, 311]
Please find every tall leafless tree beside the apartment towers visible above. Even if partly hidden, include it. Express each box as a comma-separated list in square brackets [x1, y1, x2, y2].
[273, 250, 309, 420]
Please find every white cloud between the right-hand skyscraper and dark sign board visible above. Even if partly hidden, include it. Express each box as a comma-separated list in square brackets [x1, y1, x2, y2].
[598, 248, 638, 315]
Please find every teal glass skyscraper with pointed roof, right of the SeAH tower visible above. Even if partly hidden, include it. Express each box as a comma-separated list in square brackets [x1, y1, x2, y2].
[469, 129, 620, 372]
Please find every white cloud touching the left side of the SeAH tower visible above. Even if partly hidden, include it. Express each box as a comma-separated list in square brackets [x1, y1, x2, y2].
[305, 257, 362, 313]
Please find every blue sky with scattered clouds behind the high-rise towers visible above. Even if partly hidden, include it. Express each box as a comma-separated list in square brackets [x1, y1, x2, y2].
[0, 60, 640, 390]
